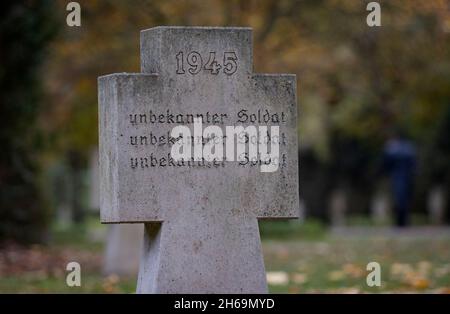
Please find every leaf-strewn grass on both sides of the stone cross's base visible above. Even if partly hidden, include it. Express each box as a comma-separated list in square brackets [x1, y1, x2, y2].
[0, 221, 450, 293]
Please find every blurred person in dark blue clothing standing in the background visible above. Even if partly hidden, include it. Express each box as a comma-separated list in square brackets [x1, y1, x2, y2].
[383, 131, 417, 227]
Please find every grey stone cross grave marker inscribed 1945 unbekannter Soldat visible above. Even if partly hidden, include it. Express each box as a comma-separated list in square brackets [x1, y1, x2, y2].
[99, 27, 299, 293]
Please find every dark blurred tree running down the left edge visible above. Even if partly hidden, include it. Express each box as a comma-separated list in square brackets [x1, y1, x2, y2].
[0, 1, 56, 243]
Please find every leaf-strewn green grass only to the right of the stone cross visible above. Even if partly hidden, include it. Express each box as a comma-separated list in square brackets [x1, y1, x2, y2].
[263, 237, 450, 293]
